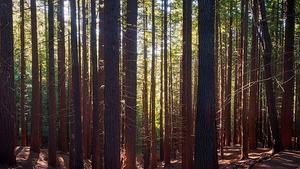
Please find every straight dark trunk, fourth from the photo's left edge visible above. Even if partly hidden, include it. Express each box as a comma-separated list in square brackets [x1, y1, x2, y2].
[48, 0, 56, 167]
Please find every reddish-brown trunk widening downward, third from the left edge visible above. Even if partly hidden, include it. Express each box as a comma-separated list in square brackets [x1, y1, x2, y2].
[30, 0, 41, 153]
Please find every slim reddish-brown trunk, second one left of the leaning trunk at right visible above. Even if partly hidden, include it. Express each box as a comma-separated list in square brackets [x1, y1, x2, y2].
[241, 0, 249, 159]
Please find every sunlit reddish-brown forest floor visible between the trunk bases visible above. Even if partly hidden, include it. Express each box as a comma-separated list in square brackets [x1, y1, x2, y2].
[0, 147, 300, 169]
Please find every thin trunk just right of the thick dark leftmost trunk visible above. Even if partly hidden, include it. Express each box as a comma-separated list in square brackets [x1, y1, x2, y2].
[20, 0, 27, 146]
